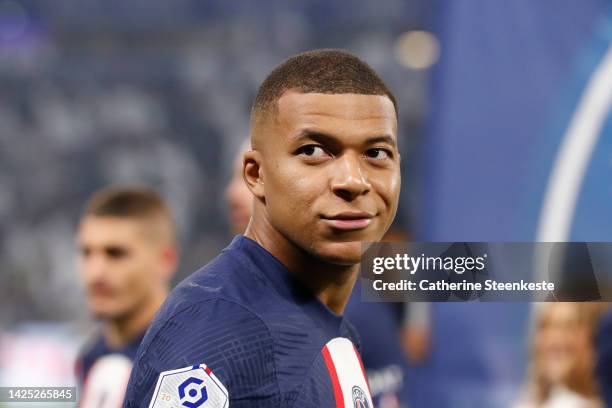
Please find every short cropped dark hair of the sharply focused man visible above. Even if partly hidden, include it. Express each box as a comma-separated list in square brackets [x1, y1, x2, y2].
[251, 49, 397, 121]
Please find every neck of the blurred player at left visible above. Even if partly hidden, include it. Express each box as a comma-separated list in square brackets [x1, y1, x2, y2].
[103, 294, 166, 349]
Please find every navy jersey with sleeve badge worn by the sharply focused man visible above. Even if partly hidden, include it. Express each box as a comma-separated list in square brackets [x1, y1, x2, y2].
[125, 236, 372, 408]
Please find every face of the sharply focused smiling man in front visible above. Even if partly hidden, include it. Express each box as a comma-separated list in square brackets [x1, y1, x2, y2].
[261, 92, 400, 265]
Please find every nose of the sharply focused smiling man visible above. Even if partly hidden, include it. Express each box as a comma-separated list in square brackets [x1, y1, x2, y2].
[331, 153, 372, 201]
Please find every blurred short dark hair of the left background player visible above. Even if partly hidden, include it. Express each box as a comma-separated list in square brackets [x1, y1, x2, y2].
[83, 186, 175, 241]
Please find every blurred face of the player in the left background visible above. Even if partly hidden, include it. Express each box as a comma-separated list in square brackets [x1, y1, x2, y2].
[77, 216, 163, 319]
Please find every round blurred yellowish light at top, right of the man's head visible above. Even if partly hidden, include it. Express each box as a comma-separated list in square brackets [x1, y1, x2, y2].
[395, 30, 440, 70]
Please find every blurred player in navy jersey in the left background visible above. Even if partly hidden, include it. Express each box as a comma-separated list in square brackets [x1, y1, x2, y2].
[77, 187, 178, 407]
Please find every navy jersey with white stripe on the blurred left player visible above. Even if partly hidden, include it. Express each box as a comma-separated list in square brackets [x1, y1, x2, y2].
[76, 333, 144, 408]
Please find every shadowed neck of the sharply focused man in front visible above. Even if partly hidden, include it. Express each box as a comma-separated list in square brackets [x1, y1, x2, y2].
[244, 217, 359, 315]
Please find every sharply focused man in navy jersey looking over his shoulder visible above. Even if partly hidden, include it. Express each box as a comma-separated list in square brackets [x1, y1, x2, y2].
[125, 50, 400, 408]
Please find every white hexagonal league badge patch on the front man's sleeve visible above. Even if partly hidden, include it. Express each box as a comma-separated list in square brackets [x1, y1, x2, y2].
[149, 364, 229, 408]
